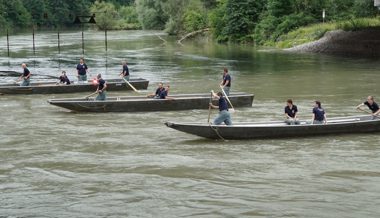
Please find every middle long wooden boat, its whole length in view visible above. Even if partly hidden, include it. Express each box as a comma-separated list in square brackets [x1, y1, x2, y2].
[48, 93, 253, 112]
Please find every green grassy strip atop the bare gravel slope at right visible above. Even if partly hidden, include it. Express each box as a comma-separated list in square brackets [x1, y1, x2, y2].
[272, 17, 380, 48]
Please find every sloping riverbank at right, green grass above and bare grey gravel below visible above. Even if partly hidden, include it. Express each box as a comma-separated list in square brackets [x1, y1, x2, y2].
[269, 18, 380, 57]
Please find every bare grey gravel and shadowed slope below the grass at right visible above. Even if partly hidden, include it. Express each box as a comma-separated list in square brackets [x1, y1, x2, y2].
[285, 28, 380, 57]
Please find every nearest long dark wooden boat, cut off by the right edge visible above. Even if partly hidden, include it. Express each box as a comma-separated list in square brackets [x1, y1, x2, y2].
[165, 115, 380, 140]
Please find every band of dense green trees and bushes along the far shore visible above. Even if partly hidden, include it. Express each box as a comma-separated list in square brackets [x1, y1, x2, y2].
[0, 0, 377, 44]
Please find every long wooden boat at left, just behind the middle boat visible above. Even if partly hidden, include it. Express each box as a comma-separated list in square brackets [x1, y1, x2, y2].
[0, 78, 149, 94]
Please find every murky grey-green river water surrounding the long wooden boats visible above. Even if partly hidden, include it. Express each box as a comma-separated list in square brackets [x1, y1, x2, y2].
[0, 31, 380, 218]
